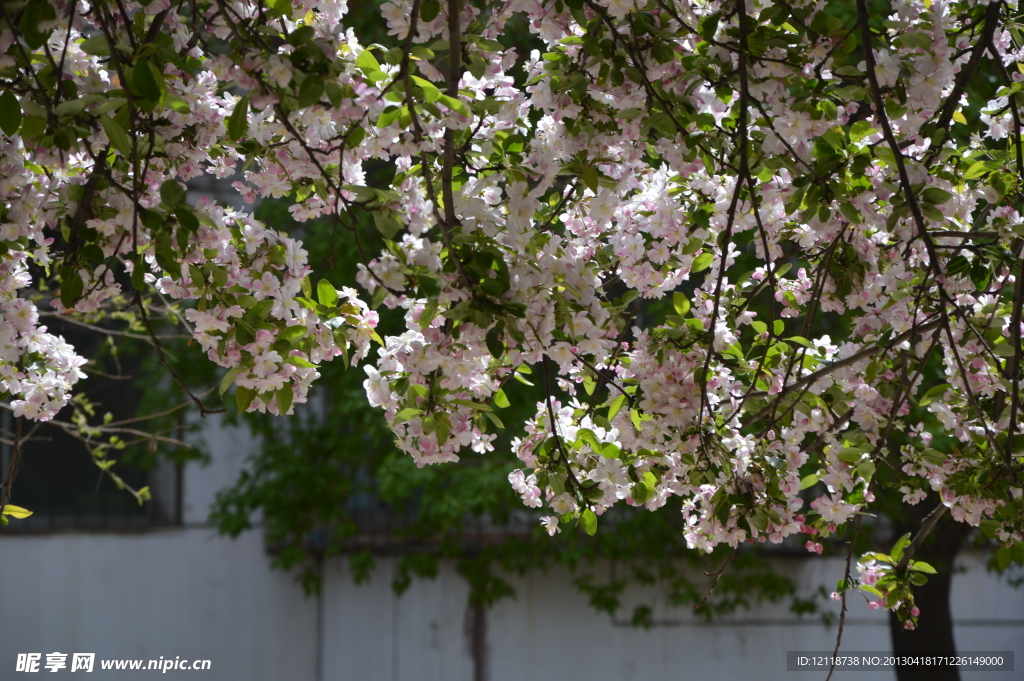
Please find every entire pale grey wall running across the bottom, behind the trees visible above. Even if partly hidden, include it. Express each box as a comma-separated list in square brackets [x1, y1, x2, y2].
[0, 417, 1024, 681]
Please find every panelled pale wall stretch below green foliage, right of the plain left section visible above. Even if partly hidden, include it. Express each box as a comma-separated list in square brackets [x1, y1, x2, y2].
[325, 555, 1024, 681]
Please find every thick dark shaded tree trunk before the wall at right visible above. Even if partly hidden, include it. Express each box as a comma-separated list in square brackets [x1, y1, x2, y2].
[889, 504, 971, 681]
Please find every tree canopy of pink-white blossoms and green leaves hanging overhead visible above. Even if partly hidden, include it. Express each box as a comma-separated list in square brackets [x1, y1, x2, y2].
[0, 0, 1024, 643]
